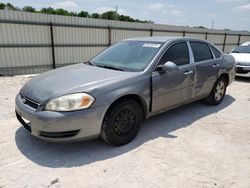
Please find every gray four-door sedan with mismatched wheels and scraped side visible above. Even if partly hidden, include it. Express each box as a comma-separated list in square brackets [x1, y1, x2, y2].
[16, 37, 235, 146]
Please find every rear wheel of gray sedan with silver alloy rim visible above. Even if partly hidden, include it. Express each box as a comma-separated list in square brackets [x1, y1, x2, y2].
[206, 77, 227, 105]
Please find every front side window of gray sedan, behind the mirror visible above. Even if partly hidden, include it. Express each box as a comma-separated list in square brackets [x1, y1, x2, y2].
[159, 42, 189, 66]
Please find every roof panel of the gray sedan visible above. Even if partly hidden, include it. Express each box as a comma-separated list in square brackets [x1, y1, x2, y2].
[125, 36, 204, 42]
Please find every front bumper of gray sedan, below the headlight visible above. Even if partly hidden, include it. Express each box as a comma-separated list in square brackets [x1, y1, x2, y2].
[16, 95, 106, 142]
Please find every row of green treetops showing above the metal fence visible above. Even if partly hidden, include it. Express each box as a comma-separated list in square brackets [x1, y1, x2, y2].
[0, 3, 154, 23]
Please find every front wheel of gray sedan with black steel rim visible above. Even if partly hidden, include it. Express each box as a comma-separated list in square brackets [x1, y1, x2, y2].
[101, 99, 143, 146]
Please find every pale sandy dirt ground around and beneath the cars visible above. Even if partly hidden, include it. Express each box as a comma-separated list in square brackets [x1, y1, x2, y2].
[0, 76, 250, 188]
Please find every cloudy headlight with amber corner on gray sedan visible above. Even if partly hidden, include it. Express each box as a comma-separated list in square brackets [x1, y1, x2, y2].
[45, 93, 95, 111]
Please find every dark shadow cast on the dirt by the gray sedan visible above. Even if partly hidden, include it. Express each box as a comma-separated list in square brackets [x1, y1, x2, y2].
[15, 95, 235, 168]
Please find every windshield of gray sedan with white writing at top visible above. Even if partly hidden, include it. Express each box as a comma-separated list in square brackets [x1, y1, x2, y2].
[90, 41, 163, 71]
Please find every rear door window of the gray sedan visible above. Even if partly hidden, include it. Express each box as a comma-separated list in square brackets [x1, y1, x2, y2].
[190, 42, 213, 62]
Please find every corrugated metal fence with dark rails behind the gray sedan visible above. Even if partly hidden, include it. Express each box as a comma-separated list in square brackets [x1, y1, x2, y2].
[0, 10, 250, 75]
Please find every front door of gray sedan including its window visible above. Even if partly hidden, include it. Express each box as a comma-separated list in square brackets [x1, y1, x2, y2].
[152, 41, 195, 113]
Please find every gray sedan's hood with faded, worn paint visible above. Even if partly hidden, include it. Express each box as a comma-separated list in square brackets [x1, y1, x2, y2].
[20, 63, 138, 104]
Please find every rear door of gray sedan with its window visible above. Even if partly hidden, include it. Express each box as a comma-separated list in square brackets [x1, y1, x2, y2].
[190, 41, 221, 98]
